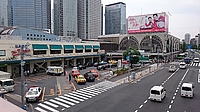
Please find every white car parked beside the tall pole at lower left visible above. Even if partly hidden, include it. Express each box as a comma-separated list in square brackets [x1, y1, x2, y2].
[25, 86, 42, 102]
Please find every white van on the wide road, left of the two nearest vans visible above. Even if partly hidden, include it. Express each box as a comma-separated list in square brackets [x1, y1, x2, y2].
[149, 86, 166, 102]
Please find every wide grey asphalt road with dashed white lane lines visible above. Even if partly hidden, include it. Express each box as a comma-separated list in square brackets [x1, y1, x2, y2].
[67, 51, 200, 112]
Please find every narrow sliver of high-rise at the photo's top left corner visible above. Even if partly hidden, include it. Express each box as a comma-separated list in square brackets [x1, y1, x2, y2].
[0, 0, 11, 26]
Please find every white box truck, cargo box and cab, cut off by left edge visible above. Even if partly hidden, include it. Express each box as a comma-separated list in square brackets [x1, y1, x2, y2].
[0, 71, 15, 92]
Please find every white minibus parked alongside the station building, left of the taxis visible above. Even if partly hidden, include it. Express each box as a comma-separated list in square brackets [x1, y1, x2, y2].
[46, 66, 63, 75]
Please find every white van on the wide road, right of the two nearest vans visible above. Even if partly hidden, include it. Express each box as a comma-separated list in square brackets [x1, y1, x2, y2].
[181, 83, 194, 98]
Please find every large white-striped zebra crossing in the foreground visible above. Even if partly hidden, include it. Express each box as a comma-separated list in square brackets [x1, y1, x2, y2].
[34, 81, 121, 112]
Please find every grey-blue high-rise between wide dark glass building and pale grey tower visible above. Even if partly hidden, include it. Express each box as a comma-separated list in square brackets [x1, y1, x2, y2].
[54, 0, 78, 37]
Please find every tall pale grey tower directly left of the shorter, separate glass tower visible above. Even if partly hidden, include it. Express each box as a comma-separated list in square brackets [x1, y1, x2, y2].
[78, 0, 103, 39]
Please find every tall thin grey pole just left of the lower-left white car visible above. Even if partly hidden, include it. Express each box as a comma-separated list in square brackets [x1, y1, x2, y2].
[20, 46, 25, 109]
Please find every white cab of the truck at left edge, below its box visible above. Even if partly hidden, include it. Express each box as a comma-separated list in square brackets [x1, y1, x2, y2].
[0, 79, 15, 92]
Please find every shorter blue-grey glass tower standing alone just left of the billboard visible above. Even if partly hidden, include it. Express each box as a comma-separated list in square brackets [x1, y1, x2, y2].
[105, 2, 126, 34]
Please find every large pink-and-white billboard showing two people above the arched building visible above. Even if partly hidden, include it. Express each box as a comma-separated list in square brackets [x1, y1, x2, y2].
[127, 12, 168, 34]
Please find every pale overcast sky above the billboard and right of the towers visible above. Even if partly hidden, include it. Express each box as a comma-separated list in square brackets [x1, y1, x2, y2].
[102, 0, 200, 39]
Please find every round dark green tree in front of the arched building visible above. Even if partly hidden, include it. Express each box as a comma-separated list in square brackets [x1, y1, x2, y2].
[123, 48, 141, 67]
